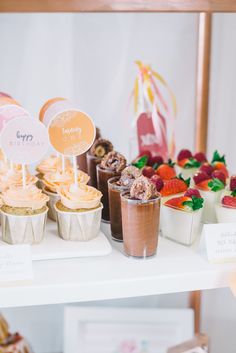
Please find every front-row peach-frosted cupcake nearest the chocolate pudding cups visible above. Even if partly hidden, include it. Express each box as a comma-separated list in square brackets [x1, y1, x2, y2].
[55, 184, 103, 241]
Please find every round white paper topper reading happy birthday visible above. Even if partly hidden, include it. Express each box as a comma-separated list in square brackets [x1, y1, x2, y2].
[1, 117, 49, 164]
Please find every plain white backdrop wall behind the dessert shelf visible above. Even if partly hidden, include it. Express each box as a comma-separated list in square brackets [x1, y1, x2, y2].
[0, 14, 236, 353]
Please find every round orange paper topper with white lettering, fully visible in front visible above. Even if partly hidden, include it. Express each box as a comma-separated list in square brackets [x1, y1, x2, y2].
[48, 109, 96, 156]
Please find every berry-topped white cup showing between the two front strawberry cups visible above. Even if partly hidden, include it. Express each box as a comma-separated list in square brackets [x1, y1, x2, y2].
[193, 170, 226, 223]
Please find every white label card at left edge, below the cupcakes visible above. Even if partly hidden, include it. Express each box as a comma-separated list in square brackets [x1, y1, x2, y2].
[0, 245, 33, 285]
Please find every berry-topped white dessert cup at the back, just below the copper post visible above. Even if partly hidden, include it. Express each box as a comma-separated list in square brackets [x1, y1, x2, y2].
[176, 149, 207, 178]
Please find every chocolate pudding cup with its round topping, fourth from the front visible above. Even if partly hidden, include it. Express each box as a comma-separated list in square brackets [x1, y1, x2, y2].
[87, 138, 113, 188]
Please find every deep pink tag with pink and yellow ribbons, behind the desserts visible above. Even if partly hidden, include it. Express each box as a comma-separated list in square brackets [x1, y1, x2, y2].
[132, 61, 177, 159]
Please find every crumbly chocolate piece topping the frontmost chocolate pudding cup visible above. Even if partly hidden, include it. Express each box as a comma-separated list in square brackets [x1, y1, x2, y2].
[130, 175, 157, 200]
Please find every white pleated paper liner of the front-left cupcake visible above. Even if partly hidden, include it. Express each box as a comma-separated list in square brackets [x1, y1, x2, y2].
[1, 208, 48, 244]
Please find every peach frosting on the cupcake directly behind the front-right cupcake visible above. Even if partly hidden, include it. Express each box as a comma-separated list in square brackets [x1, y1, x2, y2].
[42, 168, 90, 192]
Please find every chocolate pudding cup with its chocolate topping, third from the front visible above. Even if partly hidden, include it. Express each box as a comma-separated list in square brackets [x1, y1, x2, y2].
[97, 151, 126, 222]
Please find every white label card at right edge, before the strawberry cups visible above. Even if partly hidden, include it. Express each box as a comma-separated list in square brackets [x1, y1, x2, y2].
[203, 223, 236, 263]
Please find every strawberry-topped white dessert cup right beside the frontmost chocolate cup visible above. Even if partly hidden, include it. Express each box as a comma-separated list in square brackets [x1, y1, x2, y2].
[161, 189, 204, 245]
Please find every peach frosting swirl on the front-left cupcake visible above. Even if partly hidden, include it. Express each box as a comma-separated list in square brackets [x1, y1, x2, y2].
[2, 185, 49, 210]
